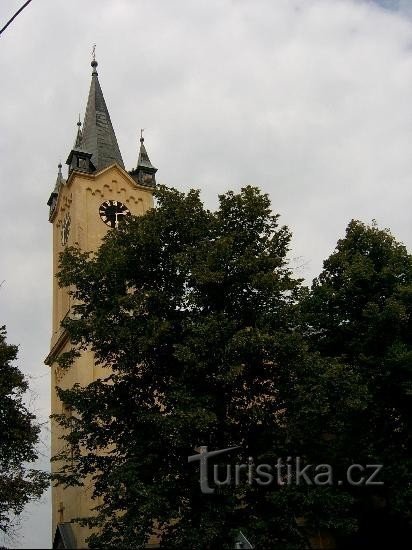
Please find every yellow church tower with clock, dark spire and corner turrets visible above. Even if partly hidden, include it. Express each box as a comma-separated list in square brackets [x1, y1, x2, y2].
[45, 55, 156, 548]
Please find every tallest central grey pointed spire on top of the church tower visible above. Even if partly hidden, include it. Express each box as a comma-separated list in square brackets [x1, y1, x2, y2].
[82, 54, 124, 170]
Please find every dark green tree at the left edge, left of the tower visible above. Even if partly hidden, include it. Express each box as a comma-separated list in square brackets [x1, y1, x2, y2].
[0, 326, 48, 534]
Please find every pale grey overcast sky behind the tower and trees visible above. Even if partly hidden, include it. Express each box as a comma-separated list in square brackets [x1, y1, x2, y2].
[0, 0, 412, 548]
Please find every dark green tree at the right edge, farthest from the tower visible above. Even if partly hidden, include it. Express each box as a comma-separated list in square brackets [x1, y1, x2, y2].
[306, 221, 412, 548]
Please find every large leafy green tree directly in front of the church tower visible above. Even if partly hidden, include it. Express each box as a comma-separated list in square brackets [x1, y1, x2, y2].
[57, 187, 312, 548]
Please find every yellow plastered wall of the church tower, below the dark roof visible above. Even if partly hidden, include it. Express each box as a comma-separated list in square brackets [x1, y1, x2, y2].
[46, 164, 153, 548]
